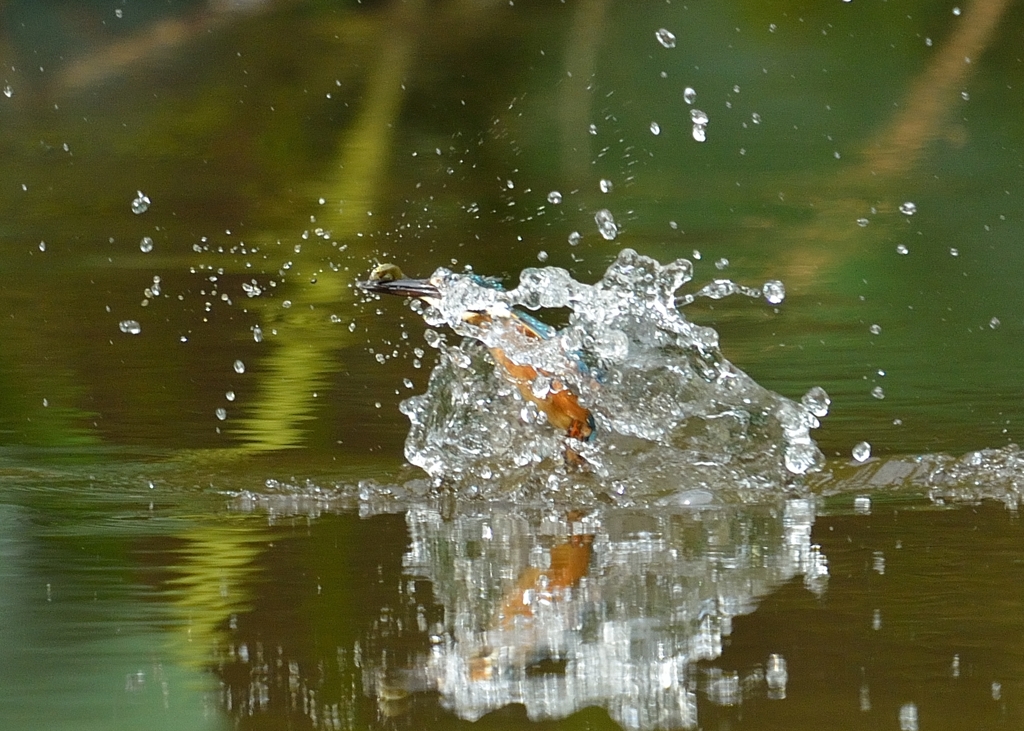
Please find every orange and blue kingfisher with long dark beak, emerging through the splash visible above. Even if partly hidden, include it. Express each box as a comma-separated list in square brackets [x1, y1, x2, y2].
[359, 264, 594, 440]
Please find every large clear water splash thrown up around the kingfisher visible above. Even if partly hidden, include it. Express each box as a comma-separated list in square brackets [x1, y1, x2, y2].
[385, 249, 827, 503]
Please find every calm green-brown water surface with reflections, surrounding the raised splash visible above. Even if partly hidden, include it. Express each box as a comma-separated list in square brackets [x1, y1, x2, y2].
[0, 0, 1024, 729]
